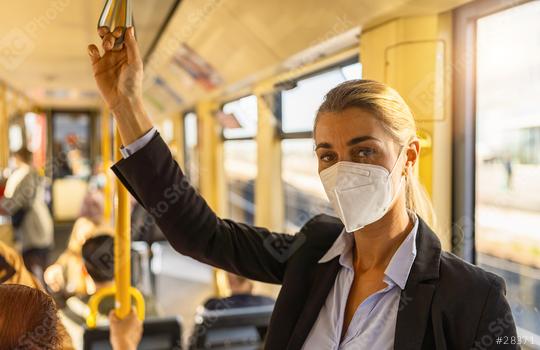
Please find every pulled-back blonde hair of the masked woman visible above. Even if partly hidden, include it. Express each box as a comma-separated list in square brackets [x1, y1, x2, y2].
[313, 80, 435, 227]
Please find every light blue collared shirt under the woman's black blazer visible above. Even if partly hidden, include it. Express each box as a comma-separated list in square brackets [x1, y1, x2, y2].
[302, 214, 418, 350]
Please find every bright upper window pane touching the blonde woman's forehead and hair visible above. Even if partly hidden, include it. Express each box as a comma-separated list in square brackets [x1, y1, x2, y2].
[281, 63, 362, 134]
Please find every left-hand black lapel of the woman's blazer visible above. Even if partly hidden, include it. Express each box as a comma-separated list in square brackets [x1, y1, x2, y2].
[287, 256, 341, 350]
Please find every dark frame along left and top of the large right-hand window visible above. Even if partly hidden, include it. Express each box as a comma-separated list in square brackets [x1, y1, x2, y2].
[452, 0, 532, 264]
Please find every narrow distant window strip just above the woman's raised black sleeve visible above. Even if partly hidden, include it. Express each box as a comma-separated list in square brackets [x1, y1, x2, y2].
[184, 112, 199, 187]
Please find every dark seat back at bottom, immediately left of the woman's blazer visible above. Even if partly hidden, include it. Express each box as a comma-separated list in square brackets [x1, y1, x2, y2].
[189, 305, 274, 350]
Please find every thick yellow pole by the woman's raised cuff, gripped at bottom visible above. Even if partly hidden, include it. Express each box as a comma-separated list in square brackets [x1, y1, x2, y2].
[114, 131, 131, 319]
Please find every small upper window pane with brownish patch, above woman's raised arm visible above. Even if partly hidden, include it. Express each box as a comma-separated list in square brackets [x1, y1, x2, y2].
[218, 95, 258, 139]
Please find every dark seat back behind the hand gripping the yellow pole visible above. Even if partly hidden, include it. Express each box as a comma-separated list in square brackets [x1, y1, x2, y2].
[83, 317, 183, 350]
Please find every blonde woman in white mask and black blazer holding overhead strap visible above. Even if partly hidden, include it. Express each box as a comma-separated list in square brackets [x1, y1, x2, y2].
[89, 28, 516, 350]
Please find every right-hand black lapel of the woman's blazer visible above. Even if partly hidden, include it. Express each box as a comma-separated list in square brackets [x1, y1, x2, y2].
[394, 218, 441, 350]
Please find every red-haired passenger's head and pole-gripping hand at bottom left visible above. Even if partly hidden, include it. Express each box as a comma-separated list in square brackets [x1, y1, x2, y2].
[0, 284, 142, 350]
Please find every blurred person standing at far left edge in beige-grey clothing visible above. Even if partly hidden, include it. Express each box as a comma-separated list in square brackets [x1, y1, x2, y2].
[0, 148, 53, 282]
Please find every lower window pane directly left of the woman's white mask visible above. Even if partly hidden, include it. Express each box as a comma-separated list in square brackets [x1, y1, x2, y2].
[281, 139, 332, 233]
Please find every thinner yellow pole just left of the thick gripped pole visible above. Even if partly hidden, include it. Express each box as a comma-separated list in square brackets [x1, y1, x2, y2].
[101, 106, 113, 224]
